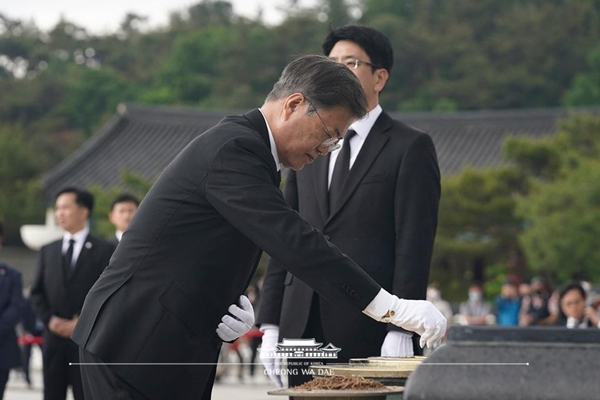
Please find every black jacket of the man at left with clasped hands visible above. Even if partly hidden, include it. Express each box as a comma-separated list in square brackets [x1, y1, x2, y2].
[31, 235, 115, 346]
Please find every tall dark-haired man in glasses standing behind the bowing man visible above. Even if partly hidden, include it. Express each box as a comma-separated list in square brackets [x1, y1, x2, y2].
[257, 25, 440, 386]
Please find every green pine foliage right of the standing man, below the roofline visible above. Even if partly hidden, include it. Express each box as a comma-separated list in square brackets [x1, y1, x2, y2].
[432, 114, 600, 299]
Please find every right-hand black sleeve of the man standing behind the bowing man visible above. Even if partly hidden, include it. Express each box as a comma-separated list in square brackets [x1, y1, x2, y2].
[388, 134, 441, 330]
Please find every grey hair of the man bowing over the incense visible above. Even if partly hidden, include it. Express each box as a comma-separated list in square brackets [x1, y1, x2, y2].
[266, 55, 369, 119]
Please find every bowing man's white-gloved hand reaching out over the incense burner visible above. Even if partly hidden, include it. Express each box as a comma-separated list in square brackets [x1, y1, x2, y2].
[363, 289, 448, 348]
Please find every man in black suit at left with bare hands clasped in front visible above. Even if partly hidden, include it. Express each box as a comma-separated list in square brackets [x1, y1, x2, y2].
[31, 188, 114, 400]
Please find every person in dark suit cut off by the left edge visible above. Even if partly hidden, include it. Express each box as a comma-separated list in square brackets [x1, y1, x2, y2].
[0, 224, 24, 400]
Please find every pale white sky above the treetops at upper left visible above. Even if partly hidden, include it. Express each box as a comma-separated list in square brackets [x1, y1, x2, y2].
[0, 0, 317, 34]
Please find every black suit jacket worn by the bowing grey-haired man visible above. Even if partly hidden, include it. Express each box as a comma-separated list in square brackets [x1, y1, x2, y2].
[73, 110, 380, 399]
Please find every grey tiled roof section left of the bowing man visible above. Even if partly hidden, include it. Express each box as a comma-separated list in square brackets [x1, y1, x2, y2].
[42, 104, 226, 200]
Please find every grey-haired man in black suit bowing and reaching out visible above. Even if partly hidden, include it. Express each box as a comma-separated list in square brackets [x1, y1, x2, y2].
[72, 55, 446, 400]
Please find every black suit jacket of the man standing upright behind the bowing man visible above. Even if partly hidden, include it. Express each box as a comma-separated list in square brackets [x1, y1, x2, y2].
[257, 112, 440, 359]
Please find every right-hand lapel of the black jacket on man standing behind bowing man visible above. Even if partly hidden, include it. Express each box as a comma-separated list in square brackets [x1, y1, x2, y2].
[325, 111, 392, 222]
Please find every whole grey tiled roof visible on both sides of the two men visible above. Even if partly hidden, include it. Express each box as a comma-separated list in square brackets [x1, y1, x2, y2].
[42, 104, 600, 200]
